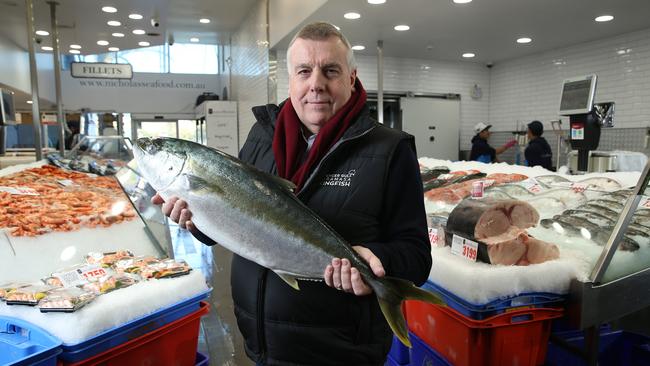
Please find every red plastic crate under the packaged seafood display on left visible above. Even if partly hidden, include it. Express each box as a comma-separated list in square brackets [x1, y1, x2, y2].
[59, 301, 210, 366]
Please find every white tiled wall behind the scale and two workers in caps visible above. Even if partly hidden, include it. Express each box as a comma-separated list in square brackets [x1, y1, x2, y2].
[489, 29, 650, 131]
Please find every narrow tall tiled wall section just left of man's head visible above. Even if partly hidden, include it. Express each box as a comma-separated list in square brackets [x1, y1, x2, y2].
[231, 0, 269, 148]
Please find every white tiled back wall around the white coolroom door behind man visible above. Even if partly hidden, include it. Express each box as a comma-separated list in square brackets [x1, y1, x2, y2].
[277, 50, 490, 149]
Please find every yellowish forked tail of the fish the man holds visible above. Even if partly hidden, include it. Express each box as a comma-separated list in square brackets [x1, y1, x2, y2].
[368, 277, 446, 347]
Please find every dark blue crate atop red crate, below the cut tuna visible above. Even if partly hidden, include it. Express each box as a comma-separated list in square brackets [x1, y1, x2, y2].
[422, 281, 566, 320]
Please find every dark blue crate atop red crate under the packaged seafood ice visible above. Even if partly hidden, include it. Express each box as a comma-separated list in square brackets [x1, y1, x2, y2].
[59, 290, 211, 363]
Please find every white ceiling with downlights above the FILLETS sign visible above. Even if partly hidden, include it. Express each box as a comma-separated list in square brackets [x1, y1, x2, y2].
[0, 0, 256, 54]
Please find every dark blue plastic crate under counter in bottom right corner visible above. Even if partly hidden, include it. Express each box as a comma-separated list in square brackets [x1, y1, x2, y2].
[546, 328, 650, 366]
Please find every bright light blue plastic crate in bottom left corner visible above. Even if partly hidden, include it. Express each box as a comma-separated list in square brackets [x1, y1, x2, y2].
[0, 316, 61, 366]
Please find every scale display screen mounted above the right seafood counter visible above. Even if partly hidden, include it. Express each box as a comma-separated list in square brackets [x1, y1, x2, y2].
[560, 75, 596, 116]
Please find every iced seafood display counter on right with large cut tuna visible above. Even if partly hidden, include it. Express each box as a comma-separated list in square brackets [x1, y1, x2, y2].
[420, 158, 650, 364]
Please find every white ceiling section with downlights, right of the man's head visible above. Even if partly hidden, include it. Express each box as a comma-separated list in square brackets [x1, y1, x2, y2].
[271, 0, 650, 63]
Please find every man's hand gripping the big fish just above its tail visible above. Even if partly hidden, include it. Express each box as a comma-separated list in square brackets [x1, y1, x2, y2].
[323, 246, 386, 296]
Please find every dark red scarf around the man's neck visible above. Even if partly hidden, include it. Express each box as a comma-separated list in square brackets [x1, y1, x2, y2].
[273, 79, 367, 191]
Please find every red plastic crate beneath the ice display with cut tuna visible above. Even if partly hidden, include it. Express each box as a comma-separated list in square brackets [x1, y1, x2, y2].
[406, 301, 564, 366]
